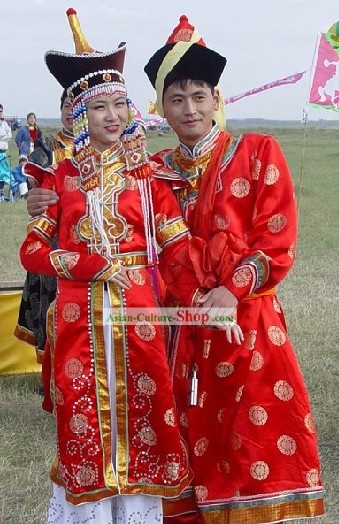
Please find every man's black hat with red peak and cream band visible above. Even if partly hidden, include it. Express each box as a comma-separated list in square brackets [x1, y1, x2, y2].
[144, 15, 227, 129]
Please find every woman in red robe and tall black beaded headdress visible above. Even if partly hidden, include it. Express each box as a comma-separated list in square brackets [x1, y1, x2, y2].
[20, 9, 199, 524]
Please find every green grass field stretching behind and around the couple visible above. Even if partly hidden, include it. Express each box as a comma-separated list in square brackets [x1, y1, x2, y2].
[0, 125, 339, 524]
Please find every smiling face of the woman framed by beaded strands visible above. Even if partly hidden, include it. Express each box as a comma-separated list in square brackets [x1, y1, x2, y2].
[87, 93, 128, 152]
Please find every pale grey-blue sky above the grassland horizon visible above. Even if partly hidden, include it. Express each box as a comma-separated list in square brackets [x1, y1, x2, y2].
[0, 0, 339, 122]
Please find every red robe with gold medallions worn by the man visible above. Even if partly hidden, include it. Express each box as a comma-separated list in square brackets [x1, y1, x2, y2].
[154, 128, 323, 524]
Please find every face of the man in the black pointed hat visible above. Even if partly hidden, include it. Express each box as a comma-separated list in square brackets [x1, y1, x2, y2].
[163, 80, 219, 149]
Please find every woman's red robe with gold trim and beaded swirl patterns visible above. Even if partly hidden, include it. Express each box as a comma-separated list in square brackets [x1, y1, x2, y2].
[20, 141, 202, 504]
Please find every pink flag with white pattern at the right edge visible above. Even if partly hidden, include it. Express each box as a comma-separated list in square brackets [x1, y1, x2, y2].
[309, 33, 339, 111]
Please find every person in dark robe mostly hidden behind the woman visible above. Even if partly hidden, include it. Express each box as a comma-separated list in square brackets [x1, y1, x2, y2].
[14, 90, 74, 363]
